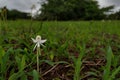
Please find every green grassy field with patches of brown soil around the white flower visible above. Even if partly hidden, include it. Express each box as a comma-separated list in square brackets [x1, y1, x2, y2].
[0, 20, 120, 80]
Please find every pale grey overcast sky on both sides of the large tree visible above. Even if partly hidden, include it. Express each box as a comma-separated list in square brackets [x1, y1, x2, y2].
[0, 0, 120, 12]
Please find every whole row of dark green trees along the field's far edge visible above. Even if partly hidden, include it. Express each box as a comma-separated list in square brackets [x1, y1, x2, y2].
[0, 0, 120, 20]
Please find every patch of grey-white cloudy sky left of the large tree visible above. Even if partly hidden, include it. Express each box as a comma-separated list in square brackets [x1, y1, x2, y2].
[0, 0, 40, 12]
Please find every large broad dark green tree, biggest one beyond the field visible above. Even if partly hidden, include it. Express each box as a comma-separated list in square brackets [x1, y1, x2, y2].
[39, 0, 114, 20]
